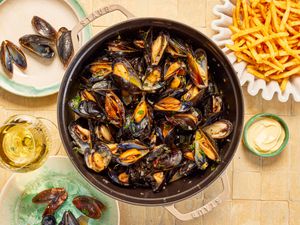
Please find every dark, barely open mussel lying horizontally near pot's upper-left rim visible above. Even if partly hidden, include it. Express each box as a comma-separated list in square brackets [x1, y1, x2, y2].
[107, 39, 139, 57]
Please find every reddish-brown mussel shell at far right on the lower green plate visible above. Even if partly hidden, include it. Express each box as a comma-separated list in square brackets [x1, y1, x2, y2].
[72, 196, 105, 219]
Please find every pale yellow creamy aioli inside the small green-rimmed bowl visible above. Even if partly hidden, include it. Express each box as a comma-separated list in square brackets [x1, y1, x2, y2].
[247, 117, 285, 154]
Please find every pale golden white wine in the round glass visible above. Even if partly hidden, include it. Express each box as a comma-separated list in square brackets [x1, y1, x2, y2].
[0, 118, 50, 172]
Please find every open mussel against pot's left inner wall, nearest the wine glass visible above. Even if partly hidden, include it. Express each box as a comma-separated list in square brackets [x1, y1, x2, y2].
[68, 118, 91, 154]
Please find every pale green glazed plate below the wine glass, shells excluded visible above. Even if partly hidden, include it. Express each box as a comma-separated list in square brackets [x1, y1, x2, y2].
[0, 156, 120, 225]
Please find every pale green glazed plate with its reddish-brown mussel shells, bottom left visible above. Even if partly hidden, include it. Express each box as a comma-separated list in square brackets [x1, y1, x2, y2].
[0, 156, 119, 225]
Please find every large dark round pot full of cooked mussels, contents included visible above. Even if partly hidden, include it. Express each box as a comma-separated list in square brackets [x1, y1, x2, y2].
[58, 5, 243, 220]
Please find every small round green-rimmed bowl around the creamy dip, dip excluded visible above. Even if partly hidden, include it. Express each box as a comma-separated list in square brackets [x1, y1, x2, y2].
[243, 113, 290, 157]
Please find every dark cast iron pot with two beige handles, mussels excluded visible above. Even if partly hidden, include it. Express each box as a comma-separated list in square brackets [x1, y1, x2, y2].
[58, 5, 244, 220]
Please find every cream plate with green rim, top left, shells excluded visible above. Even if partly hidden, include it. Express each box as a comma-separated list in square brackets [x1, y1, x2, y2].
[0, 0, 92, 97]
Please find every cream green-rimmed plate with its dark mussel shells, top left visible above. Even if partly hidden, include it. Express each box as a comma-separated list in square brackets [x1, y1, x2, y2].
[0, 0, 91, 97]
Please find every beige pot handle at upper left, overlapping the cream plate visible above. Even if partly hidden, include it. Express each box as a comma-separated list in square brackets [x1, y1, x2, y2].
[71, 4, 134, 51]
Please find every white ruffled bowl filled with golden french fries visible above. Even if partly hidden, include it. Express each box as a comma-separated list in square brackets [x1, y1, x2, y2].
[212, 0, 300, 102]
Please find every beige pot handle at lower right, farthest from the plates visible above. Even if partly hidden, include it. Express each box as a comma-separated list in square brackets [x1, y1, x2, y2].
[165, 172, 229, 221]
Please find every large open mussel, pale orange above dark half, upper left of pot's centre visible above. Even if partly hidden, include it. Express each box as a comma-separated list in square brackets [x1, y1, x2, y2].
[112, 58, 142, 94]
